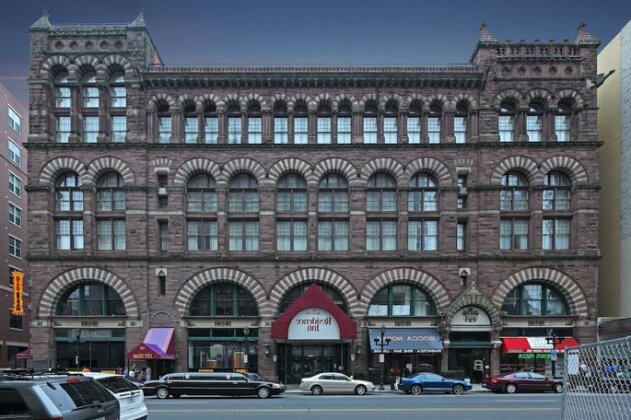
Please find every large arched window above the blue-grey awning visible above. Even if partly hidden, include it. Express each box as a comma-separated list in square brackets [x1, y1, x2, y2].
[368, 284, 436, 316]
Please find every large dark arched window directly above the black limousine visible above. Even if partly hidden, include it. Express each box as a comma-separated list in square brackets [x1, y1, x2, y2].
[189, 283, 258, 316]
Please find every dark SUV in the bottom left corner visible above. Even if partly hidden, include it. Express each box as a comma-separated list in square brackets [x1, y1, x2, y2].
[0, 374, 120, 420]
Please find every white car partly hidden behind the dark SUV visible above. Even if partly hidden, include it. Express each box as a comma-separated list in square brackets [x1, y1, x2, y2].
[77, 372, 147, 420]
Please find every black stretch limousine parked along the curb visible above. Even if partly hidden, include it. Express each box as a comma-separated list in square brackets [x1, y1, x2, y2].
[142, 372, 285, 399]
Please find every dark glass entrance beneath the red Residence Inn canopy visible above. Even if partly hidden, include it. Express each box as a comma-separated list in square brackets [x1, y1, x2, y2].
[278, 344, 344, 384]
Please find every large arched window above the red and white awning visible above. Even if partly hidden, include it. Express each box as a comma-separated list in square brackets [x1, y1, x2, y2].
[502, 282, 570, 316]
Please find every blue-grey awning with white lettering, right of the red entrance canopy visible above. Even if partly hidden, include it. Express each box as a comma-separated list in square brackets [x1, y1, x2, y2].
[369, 328, 443, 353]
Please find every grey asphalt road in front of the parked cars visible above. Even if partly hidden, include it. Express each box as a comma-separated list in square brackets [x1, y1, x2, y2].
[145, 392, 561, 420]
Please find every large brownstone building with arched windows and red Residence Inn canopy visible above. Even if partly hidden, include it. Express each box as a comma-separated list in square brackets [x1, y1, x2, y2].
[28, 10, 599, 382]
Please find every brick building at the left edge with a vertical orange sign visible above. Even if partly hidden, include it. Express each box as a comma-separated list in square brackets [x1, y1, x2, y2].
[0, 84, 30, 367]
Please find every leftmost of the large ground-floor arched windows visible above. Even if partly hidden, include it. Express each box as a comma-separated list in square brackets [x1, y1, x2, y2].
[55, 283, 125, 316]
